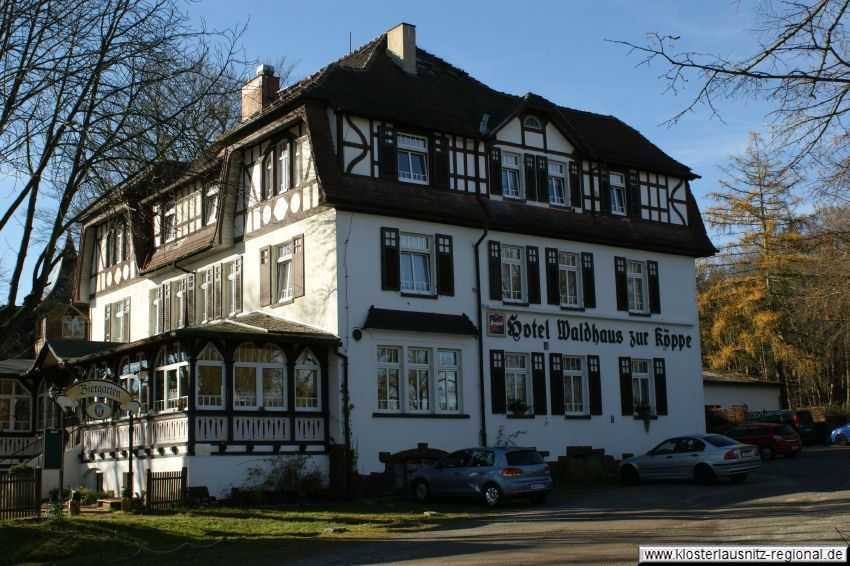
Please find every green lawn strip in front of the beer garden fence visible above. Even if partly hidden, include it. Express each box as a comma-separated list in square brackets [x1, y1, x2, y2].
[0, 500, 480, 566]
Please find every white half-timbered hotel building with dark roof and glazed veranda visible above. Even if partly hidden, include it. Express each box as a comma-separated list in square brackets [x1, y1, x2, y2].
[9, 24, 714, 500]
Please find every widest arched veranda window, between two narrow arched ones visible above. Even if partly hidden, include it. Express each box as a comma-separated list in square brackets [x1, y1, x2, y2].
[233, 344, 286, 410]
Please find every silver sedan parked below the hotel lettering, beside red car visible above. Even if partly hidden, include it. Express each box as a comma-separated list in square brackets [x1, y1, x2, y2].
[620, 434, 761, 485]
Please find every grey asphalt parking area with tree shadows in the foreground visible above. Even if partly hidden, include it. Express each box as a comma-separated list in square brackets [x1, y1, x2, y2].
[290, 447, 850, 565]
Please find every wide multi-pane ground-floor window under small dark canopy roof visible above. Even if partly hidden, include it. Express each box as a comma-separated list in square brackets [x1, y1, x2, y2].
[377, 346, 461, 414]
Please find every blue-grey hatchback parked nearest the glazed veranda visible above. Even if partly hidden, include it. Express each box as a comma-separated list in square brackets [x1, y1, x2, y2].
[410, 446, 552, 507]
